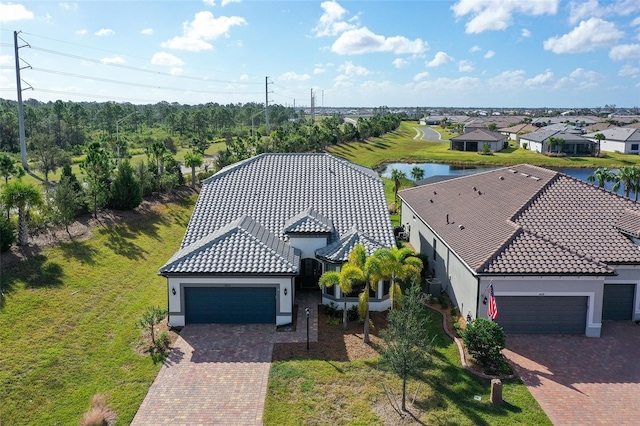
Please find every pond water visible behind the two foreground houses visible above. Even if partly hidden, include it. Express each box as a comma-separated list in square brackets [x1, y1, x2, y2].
[378, 163, 635, 200]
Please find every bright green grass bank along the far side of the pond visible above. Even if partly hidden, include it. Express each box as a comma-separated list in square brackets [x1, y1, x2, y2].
[329, 121, 640, 169]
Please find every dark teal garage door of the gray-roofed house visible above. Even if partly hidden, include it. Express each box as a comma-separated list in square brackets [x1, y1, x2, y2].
[184, 287, 276, 324]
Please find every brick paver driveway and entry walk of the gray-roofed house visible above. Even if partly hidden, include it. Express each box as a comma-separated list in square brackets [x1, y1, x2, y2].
[132, 293, 320, 425]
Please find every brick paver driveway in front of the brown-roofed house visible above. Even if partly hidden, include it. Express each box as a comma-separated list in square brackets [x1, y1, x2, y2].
[504, 321, 640, 426]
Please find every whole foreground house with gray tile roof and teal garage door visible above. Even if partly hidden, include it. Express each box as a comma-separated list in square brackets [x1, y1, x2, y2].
[159, 154, 395, 326]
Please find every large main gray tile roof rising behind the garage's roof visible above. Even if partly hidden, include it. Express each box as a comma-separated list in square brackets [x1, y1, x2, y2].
[161, 154, 395, 272]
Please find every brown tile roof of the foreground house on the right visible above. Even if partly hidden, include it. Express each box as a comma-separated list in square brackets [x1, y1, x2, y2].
[399, 165, 640, 274]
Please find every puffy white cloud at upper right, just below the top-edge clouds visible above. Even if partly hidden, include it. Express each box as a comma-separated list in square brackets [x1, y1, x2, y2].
[544, 18, 624, 54]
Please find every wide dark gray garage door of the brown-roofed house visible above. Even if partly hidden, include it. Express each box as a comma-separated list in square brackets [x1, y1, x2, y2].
[496, 296, 587, 334]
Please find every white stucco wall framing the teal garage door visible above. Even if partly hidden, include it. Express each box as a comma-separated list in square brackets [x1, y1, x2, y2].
[167, 276, 294, 327]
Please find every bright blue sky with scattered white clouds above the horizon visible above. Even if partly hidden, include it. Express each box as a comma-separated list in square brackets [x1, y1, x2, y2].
[0, 0, 640, 108]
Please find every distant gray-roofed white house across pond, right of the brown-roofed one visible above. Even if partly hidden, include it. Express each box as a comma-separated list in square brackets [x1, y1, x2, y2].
[520, 128, 596, 155]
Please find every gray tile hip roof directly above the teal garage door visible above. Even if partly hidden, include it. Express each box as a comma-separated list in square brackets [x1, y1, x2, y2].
[160, 216, 300, 274]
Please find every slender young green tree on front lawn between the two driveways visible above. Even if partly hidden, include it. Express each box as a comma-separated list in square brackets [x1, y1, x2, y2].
[380, 284, 432, 411]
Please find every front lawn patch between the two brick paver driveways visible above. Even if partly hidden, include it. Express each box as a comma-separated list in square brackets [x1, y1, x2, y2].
[263, 311, 551, 425]
